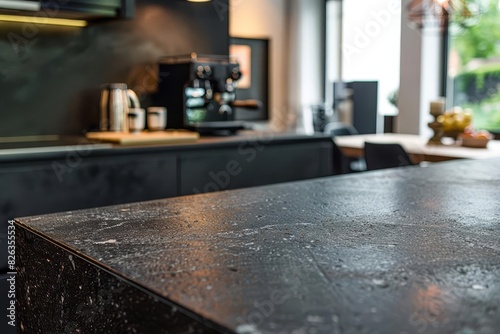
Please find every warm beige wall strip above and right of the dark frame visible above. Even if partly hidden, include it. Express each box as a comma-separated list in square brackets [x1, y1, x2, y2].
[229, 0, 288, 128]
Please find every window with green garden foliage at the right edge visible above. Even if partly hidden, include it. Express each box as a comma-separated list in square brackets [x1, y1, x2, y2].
[446, 0, 500, 133]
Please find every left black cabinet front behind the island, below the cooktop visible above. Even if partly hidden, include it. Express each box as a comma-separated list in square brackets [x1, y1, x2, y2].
[0, 154, 176, 220]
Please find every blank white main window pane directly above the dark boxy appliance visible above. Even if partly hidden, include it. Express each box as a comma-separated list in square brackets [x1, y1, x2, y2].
[342, 0, 401, 126]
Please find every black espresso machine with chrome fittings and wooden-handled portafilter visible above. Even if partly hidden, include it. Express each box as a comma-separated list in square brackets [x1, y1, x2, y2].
[158, 53, 261, 133]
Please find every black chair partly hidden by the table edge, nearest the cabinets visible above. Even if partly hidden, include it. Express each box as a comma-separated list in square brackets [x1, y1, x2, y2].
[323, 122, 366, 174]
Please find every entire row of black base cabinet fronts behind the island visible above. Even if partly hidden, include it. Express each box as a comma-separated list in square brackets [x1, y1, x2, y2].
[0, 135, 333, 273]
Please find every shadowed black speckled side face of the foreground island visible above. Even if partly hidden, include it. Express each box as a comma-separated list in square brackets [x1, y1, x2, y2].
[16, 230, 224, 334]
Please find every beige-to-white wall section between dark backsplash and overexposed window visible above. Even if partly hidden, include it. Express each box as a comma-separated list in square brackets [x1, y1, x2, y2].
[229, 0, 324, 130]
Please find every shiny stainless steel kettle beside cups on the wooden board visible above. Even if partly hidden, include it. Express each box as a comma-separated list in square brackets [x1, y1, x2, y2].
[99, 83, 140, 132]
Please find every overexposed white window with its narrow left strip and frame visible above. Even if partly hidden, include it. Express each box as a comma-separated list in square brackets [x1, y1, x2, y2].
[326, 0, 401, 132]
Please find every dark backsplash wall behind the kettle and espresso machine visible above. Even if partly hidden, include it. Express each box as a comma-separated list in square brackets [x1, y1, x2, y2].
[0, 0, 229, 137]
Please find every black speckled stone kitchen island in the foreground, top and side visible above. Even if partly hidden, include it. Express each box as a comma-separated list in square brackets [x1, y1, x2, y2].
[17, 160, 500, 334]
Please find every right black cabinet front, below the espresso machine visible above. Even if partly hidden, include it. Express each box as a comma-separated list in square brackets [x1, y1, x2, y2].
[180, 141, 332, 195]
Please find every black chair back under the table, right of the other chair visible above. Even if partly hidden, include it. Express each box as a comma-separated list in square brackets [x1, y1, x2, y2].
[365, 142, 413, 170]
